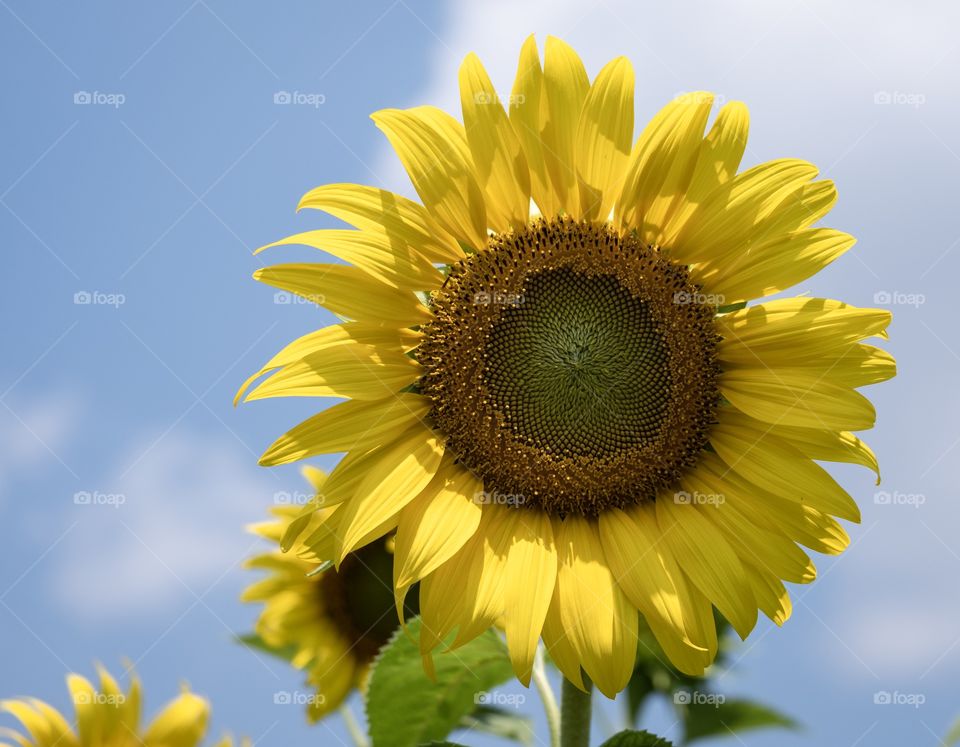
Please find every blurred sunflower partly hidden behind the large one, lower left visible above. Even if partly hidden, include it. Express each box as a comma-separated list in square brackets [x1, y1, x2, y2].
[242, 467, 416, 721]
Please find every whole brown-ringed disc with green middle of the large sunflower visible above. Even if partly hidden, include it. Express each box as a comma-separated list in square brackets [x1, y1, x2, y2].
[417, 218, 718, 515]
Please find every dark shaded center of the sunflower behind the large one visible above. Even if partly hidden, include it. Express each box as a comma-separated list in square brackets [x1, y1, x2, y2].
[320, 542, 419, 662]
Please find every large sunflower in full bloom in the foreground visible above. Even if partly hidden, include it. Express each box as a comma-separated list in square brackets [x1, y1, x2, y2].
[238, 38, 895, 697]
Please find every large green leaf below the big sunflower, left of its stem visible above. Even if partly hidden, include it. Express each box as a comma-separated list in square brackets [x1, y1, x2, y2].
[366, 618, 513, 747]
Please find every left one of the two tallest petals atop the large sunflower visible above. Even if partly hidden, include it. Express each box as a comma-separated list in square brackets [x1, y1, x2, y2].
[510, 34, 559, 217]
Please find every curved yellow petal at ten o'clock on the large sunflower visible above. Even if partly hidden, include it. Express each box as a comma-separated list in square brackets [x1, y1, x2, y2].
[297, 184, 463, 262]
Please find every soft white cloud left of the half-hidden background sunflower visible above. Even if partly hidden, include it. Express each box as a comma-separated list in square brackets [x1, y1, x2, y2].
[53, 432, 280, 622]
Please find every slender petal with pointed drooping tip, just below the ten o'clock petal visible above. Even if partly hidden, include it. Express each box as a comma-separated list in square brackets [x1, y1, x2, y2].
[255, 228, 443, 290]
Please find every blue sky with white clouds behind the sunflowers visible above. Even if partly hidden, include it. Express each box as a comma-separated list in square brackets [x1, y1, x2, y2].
[0, 0, 960, 747]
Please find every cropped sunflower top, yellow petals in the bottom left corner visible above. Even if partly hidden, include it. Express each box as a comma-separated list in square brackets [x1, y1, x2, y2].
[0, 667, 240, 747]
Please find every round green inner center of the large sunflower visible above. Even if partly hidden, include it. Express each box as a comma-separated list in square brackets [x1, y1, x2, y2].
[485, 267, 670, 457]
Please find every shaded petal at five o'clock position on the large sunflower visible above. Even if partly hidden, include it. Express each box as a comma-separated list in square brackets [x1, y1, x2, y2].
[656, 494, 757, 638]
